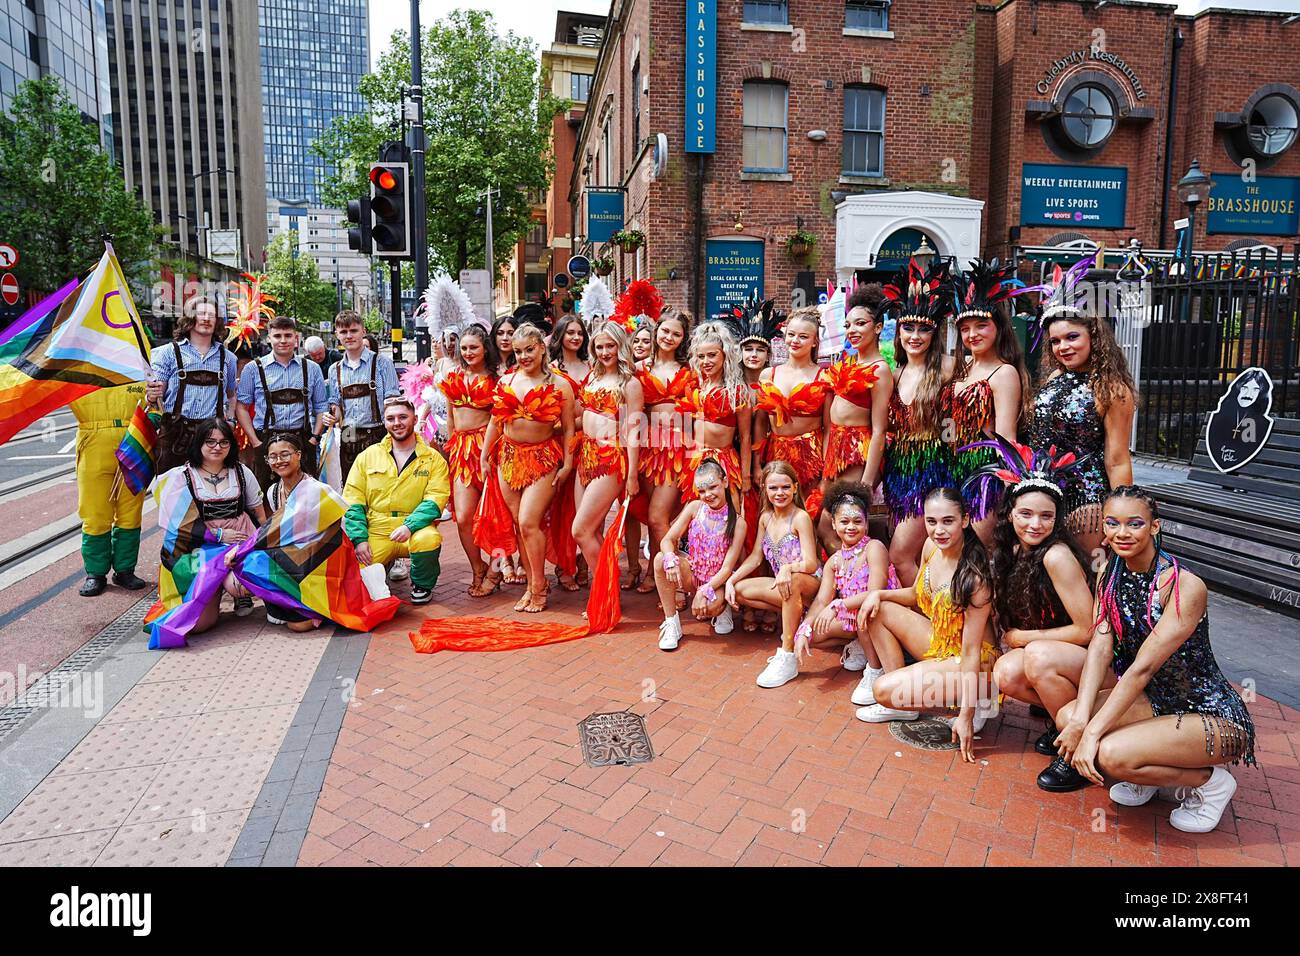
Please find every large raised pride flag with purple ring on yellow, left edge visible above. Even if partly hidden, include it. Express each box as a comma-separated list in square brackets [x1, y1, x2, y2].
[0, 245, 150, 444]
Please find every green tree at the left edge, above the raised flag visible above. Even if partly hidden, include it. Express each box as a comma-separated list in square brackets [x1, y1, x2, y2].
[0, 77, 160, 293]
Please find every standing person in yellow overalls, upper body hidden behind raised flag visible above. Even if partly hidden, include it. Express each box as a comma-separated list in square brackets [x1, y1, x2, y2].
[69, 382, 148, 597]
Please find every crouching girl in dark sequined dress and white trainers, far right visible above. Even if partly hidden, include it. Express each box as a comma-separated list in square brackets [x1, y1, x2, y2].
[1057, 485, 1255, 834]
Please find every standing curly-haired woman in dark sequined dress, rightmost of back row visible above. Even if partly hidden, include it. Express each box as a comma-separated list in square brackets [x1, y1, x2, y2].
[1028, 255, 1138, 553]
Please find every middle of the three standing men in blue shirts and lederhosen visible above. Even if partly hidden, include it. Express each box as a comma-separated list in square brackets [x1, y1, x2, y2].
[235, 315, 329, 492]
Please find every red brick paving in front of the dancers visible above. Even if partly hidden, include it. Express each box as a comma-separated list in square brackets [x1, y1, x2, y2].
[299, 544, 1300, 866]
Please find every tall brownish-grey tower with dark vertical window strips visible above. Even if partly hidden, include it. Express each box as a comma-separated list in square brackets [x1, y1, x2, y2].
[102, 0, 267, 268]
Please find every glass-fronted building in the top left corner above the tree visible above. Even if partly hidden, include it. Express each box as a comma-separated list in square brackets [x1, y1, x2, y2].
[0, 0, 113, 151]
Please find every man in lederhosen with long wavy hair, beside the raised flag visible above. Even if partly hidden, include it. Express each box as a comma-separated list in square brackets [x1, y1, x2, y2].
[144, 299, 238, 475]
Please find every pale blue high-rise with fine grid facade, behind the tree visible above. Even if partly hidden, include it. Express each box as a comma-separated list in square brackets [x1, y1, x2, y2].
[257, 0, 371, 206]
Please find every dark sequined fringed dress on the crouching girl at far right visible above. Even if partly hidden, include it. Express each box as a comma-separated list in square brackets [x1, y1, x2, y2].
[1112, 558, 1255, 763]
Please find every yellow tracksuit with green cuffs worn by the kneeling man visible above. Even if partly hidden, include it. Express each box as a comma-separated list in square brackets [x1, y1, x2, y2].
[343, 434, 451, 591]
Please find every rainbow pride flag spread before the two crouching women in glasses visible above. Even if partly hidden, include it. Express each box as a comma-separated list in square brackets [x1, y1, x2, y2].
[144, 466, 402, 650]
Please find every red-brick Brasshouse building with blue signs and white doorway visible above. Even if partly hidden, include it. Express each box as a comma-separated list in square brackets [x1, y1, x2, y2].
[569, 0, 1300, 321]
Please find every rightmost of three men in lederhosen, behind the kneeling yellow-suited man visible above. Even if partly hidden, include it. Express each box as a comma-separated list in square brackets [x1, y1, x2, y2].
[325, 310, 402, 485]
